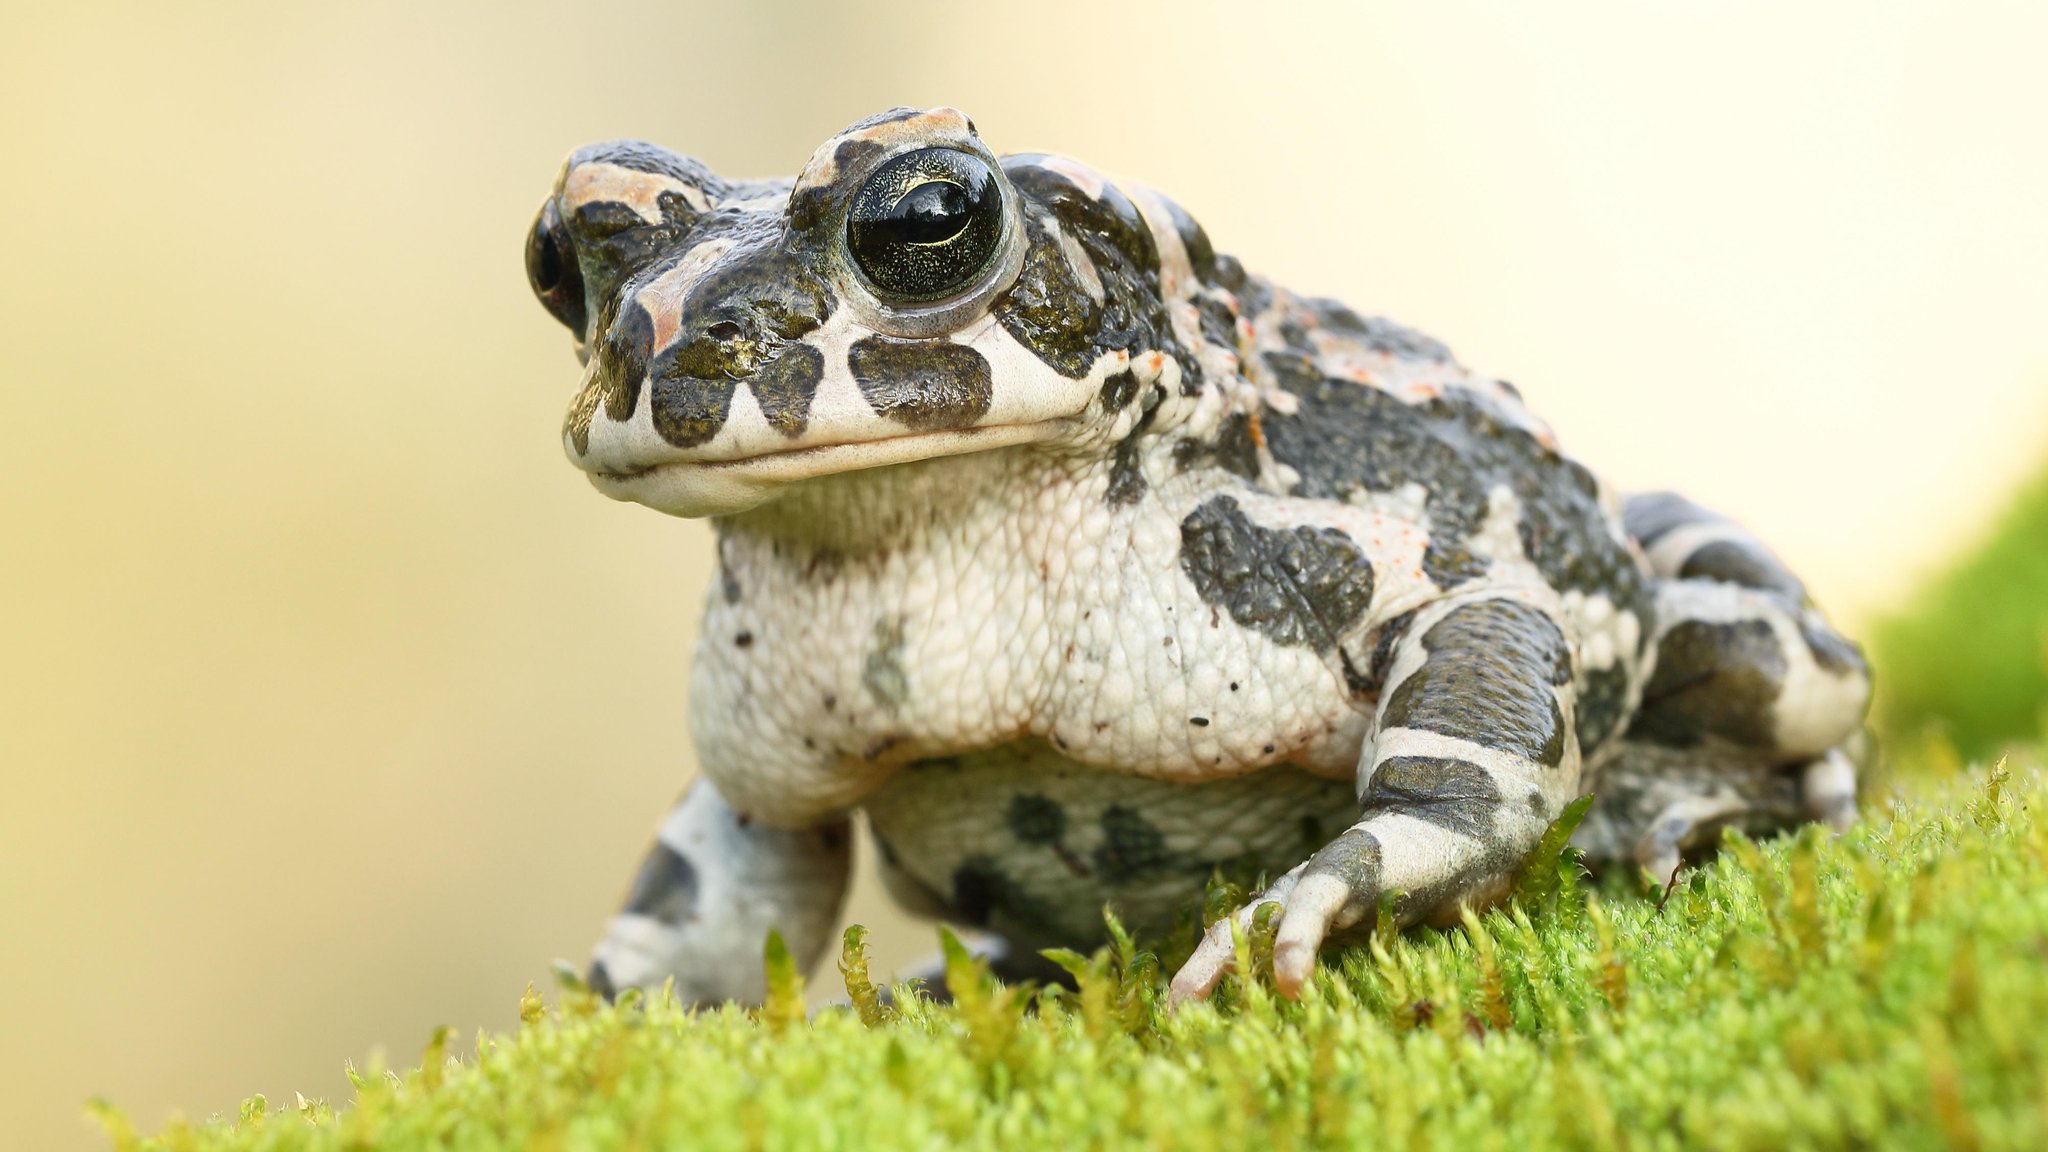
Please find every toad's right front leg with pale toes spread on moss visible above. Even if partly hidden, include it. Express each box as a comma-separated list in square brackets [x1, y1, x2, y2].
[1171, 599, 1579, 1002]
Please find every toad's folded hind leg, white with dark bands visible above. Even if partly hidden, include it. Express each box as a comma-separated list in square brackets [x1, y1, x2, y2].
[1575, 494, 1870, 877]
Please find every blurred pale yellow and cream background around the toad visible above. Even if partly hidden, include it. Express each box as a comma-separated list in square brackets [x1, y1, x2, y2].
[0, 0, 2048, 1148]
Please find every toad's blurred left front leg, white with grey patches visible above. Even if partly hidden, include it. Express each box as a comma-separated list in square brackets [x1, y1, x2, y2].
[590, 779, 852, 1004]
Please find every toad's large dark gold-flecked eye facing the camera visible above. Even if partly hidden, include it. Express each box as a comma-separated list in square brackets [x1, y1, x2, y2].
[846, 148, 1004, 303]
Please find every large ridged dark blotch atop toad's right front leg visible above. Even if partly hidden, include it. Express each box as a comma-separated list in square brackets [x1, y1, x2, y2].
[1380, 601, 1571, 767]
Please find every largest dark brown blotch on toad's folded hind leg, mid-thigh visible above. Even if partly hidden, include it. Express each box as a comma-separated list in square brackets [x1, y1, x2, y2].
[1628, 619, 1786, 748]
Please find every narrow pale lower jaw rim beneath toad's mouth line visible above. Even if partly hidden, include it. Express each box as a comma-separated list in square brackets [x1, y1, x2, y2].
[571, 420, 1069, 519]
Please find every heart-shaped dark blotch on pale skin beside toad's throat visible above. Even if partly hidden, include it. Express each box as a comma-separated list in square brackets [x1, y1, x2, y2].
[1180, 496, 1372, 652]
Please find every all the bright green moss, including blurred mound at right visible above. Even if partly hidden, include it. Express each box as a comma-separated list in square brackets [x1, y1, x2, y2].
[96, 469, 2048, 1150]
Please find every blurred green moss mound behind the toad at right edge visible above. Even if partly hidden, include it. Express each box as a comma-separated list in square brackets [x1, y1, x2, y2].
[1872, 461, 2048, 758]
